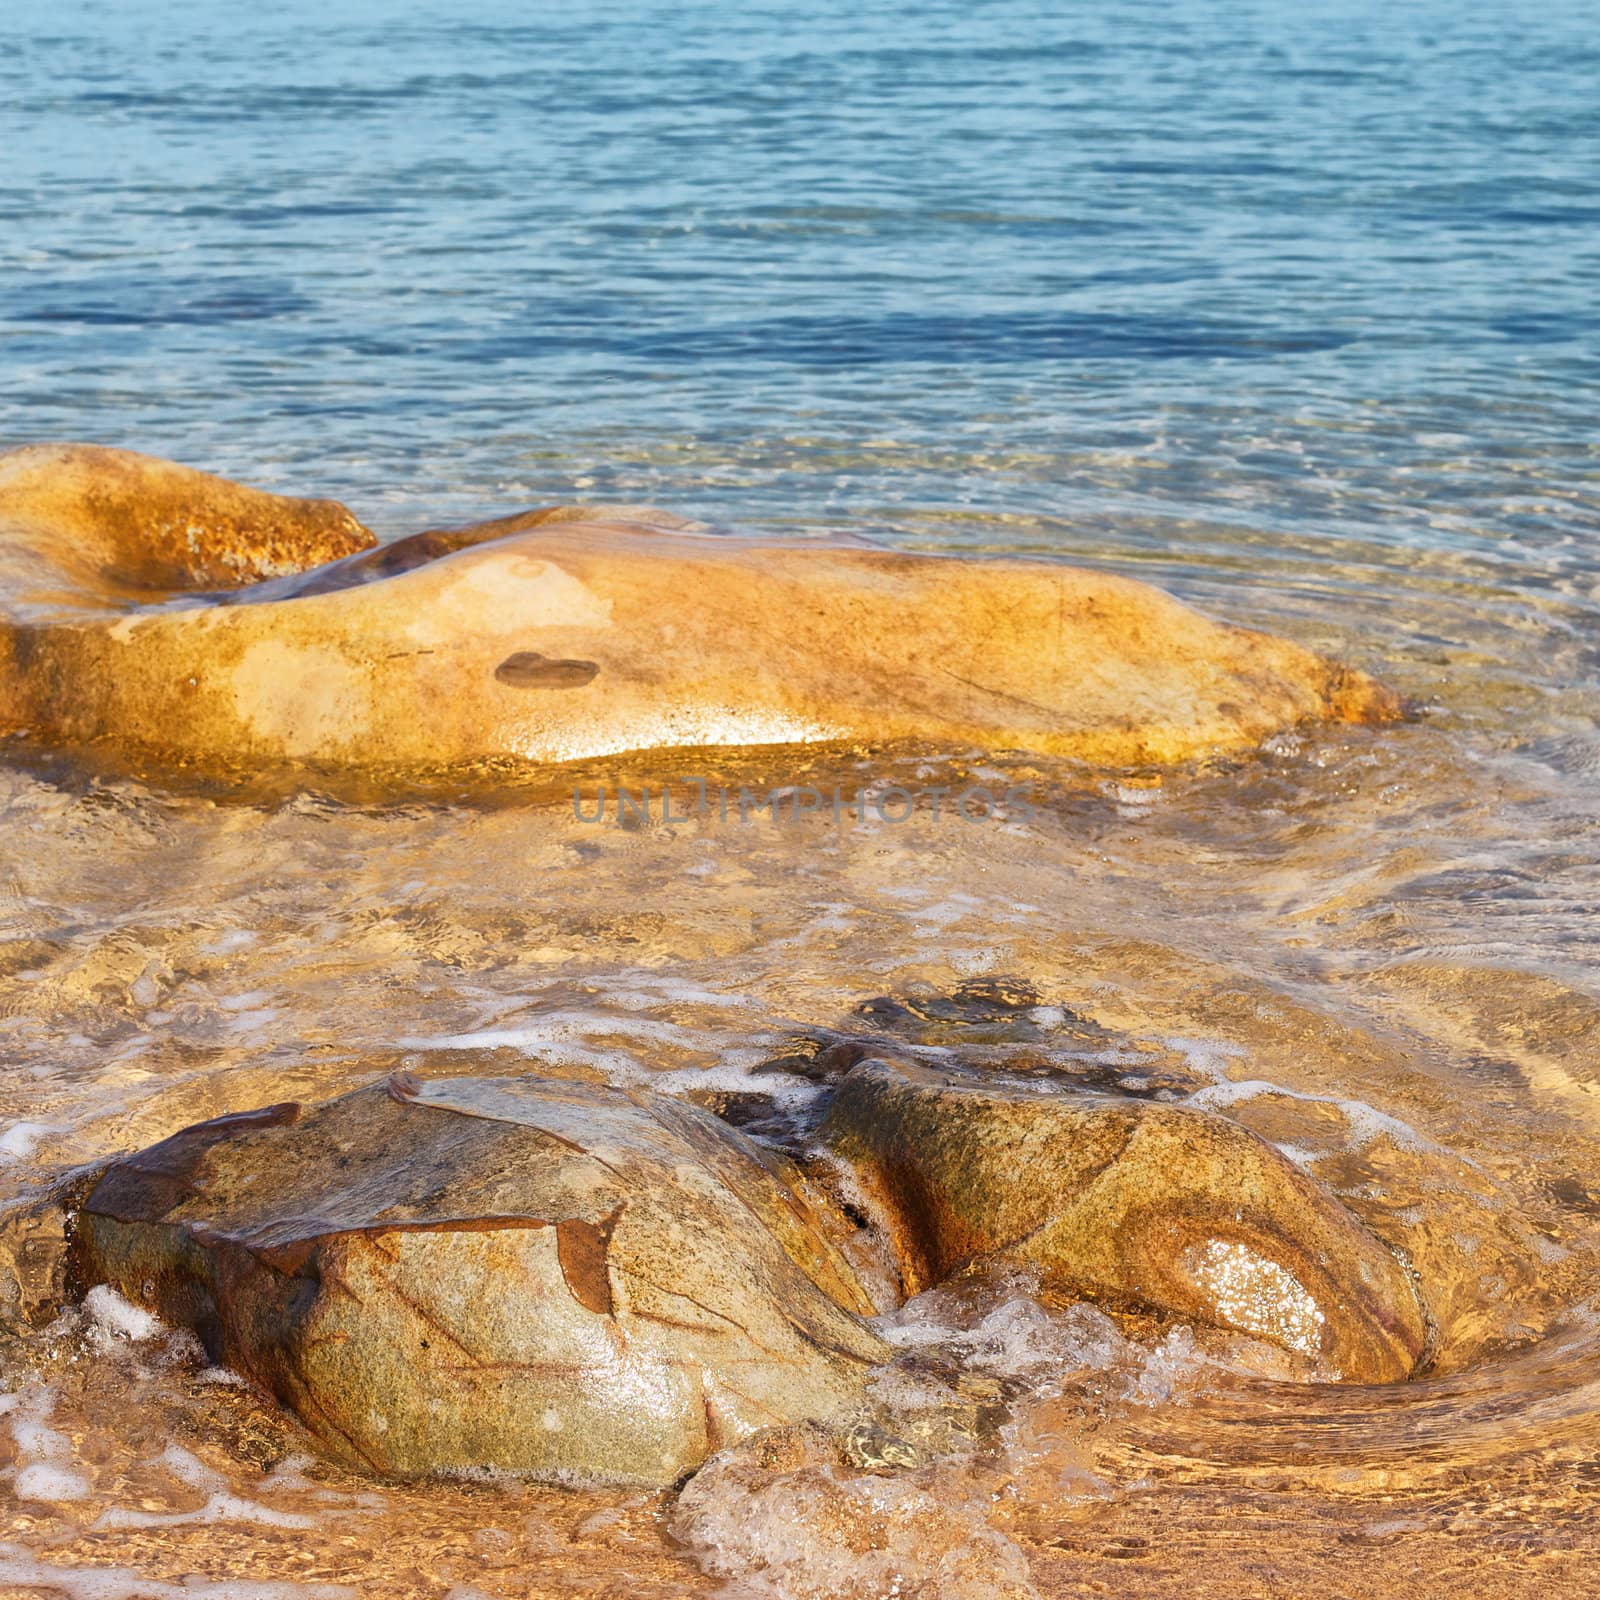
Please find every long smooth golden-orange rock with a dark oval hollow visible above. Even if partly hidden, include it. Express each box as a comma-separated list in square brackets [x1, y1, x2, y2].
[0, 446, 1397, 770]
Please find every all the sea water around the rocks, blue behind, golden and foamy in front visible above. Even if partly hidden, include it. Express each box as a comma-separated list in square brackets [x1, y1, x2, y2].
[0, 3, 1600, 1600]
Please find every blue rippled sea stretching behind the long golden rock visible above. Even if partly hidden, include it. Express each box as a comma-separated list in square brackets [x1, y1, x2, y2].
[0, 0, 1600, 587]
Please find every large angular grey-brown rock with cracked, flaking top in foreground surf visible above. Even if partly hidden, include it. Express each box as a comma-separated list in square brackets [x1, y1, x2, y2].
[75, 1077, 888, 1483]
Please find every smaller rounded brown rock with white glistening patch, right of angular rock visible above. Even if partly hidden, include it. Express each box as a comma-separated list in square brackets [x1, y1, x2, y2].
[821, 1061, 1426, 1382]
